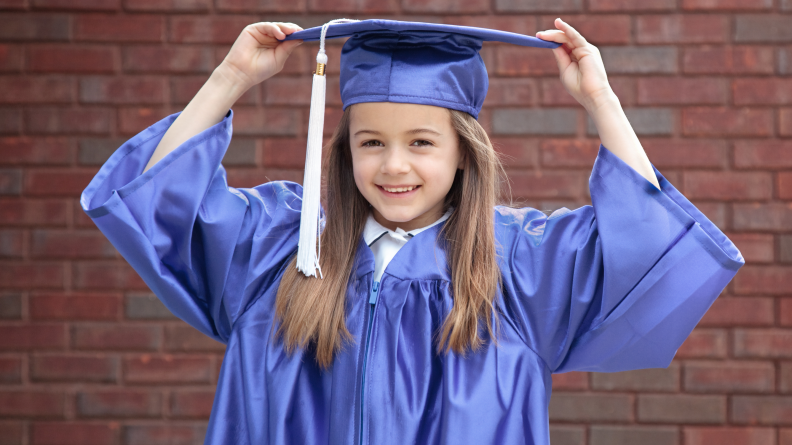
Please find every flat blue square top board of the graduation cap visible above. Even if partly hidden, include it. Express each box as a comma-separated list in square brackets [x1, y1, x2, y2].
[284, 19, 560, 48]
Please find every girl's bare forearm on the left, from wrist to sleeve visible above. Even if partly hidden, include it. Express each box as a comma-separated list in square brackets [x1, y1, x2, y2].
[143, 65, 249, 173]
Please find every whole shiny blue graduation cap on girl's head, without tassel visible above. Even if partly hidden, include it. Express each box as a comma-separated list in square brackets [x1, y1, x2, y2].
[284, 19, 559, 118]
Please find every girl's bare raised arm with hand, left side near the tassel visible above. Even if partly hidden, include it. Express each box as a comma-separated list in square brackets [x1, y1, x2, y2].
[143, 22, 302, 173]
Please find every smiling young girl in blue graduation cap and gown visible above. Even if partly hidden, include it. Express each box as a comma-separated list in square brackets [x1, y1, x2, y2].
[81, 19, 744, 444]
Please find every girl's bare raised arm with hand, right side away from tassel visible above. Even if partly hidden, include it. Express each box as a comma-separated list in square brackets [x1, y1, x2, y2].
[536, 19, 660, 189]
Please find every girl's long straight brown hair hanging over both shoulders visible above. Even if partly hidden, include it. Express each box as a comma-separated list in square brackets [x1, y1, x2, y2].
[275, 107, 505, 369]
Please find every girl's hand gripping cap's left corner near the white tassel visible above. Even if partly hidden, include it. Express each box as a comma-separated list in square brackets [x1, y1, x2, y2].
[218, 22, 303, 89]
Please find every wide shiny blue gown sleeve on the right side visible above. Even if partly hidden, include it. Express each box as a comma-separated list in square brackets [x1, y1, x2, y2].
[495, 145, 745, 373]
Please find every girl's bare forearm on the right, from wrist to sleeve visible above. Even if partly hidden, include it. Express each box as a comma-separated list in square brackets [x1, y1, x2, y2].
[587, 92, 660, 190]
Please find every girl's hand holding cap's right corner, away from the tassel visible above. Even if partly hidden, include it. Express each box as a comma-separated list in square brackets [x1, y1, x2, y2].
[536, 18, 615, 112]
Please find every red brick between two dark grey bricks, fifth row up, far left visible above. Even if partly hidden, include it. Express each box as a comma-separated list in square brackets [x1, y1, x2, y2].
[29, 292, 121, 320]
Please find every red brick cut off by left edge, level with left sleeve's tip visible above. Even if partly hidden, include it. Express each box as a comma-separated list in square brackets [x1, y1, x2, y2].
[0, 198, 67, 226]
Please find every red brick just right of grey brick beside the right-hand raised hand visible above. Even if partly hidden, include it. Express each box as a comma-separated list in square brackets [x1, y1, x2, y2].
[682, 45, 774, 74]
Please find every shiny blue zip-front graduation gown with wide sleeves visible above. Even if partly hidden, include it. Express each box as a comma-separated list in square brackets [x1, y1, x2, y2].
[81, 111, 744, 445]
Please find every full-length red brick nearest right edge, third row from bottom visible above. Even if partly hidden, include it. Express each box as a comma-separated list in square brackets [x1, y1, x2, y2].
[684, 361, 775, 393]
